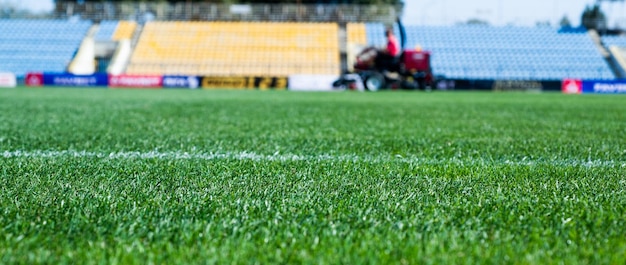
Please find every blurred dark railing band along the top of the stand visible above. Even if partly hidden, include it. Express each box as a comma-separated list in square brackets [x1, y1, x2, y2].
[41, 2, 402, 23]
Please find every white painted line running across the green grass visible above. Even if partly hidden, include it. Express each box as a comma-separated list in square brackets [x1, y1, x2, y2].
[0, 150, 626, 168]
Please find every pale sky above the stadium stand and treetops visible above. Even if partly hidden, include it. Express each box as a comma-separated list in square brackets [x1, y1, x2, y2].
[0, 0, 626, 28]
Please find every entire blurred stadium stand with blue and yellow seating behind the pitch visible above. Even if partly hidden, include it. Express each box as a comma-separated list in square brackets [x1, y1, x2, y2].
[0, 1, 626, 81]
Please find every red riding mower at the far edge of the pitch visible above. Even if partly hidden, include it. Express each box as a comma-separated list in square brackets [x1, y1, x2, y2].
[333, 19, 435, 91]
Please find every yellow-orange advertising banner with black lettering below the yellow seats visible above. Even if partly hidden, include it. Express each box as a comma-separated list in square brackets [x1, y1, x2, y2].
[201, 76, 288, 90]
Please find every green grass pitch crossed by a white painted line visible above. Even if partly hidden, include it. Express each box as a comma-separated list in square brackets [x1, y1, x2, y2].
[0, 88, 626, 264]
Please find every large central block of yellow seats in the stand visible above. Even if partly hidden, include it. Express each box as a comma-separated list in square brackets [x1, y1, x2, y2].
[127, 21, 340, 76]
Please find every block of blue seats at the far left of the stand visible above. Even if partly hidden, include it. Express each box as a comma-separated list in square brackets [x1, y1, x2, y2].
[0, 19, 92, 78]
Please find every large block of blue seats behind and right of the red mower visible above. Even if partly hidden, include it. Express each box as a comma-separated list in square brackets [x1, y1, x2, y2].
[366, 23, 615, 80]
